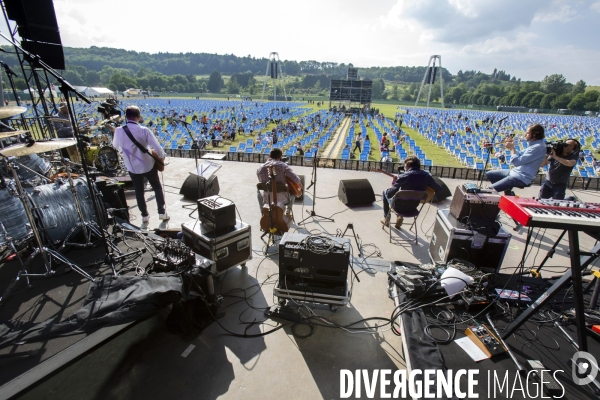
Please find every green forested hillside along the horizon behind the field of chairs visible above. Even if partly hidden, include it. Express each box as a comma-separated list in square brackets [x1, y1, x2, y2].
[2, 46, 600, 111]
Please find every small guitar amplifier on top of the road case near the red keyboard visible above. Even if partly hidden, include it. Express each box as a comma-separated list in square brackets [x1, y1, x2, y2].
[450, 185, 500, 222]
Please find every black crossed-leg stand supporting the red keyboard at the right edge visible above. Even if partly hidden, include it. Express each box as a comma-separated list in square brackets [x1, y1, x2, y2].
[502, 234, 600, 351]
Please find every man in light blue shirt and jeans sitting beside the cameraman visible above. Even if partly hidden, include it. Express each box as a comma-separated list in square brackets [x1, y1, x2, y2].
[485, 124, 546, 195]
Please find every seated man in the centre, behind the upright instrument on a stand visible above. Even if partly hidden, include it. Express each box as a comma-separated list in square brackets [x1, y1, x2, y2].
[256, 147, 301, 230]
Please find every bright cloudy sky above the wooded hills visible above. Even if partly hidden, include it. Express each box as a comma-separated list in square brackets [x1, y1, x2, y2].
[1, 0, 600, 85]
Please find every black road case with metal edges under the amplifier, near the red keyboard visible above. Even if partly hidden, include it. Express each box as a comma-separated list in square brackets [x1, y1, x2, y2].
[429, 209, 512, 272]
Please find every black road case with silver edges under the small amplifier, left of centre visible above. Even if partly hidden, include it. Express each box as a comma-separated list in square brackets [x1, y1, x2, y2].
[181, 221, 252, 275]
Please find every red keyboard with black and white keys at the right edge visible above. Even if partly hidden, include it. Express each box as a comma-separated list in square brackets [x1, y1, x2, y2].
[498, 196, 600, 232]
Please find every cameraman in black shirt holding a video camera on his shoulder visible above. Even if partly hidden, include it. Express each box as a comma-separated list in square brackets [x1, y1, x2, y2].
[538, 139, 581, 200]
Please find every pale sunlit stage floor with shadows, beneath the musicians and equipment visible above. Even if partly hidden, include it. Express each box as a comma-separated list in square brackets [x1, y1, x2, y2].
[0, 158, 597, 399]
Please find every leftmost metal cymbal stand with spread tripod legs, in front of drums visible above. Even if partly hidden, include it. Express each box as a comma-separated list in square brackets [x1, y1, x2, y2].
[2, 159, 94, 281]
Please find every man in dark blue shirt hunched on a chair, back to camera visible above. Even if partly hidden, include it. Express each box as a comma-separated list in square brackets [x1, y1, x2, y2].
[381, 156, 442, 229]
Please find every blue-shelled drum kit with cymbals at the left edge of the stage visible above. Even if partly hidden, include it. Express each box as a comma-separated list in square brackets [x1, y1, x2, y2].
[0, 107, 129, 305]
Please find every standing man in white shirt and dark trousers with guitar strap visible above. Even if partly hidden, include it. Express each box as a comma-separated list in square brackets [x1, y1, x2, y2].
[113, 106, 169, 224]
